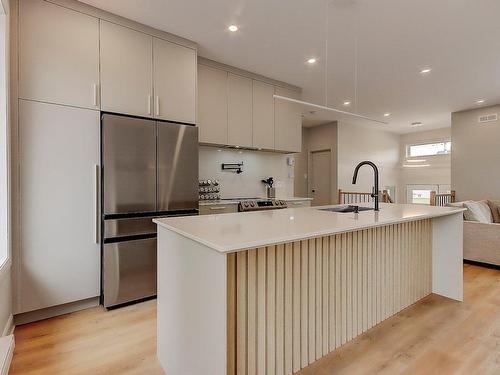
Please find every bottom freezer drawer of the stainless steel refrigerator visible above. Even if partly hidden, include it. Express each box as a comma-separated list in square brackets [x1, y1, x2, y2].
[103, 238, 156, 307]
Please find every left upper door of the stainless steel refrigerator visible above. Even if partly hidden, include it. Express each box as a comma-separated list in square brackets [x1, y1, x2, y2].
[102, 114, 156, 214]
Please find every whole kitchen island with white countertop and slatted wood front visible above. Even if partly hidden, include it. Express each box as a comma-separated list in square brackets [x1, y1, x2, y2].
[155, 204, 463, 375]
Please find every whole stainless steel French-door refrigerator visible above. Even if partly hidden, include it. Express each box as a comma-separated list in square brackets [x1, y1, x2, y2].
[101, 113, 198, 307]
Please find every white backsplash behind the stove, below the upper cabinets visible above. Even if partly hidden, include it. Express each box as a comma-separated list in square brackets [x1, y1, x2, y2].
[199, 146, 294, 198]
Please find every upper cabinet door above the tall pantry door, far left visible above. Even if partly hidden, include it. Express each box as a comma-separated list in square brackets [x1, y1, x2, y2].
[19, 0, 99, 109]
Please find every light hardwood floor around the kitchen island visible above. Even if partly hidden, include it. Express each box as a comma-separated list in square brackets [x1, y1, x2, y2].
[10, 265, 500, 375]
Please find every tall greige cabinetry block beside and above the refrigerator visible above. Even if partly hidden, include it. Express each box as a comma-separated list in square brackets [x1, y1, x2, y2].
[11, 0, 197, 316]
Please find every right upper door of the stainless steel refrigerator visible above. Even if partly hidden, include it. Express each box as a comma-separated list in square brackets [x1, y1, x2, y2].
[158, 122, 198, 211]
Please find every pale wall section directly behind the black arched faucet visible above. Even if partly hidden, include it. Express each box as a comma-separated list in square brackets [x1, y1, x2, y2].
[337, 123, 401, 200]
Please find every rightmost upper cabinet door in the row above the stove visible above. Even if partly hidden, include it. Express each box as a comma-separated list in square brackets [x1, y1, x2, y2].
[274, 87, 302, 152]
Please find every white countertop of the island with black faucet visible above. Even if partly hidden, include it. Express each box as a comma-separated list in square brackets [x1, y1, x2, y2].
[153, 203, 464, 253]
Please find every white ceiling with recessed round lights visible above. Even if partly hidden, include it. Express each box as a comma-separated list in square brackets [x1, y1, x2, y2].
[83, 0, 500, 133]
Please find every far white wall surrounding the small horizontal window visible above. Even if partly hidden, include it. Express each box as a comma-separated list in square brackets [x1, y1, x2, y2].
[398, 127, 454, 203]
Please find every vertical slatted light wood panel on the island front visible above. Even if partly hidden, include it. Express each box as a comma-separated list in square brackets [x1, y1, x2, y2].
[227, 219, 432, 375]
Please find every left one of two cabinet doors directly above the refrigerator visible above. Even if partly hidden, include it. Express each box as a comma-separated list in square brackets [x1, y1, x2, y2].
[101, 20, 153, 117]
